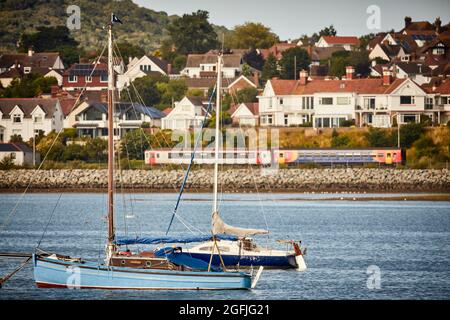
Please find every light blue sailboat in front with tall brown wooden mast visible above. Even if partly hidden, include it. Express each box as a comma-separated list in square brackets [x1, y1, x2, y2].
[32, 15, 256, 290]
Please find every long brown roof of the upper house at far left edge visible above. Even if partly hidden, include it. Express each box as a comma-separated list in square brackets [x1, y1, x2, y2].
[0, 52, 59, 69]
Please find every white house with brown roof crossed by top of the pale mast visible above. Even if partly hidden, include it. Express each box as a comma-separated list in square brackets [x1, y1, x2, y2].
[180, 53, 244, 78]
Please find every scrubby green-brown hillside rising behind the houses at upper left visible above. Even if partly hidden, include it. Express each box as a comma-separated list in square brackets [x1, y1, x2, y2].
[0, 0, 227, 51]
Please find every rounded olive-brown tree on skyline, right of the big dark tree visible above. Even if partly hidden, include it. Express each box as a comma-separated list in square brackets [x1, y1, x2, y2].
[227, 22, 280, 49]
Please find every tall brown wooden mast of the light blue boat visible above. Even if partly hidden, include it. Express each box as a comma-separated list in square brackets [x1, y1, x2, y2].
[108, 16, 114, 254]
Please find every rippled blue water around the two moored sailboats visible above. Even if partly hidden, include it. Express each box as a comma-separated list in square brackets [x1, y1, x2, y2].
[0, 194, 450, 300]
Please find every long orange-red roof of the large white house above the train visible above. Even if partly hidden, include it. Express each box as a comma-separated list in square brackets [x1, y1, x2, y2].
[270, 78, 407, 95]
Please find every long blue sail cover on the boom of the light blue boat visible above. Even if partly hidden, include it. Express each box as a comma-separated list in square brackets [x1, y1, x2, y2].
[114, 234, 238, 246]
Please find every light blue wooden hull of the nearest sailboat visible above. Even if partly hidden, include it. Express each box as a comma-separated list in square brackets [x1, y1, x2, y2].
[33, 255, 251, 290]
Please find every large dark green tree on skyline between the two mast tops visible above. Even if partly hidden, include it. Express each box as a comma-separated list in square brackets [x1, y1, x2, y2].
[167, 10, 218, 55]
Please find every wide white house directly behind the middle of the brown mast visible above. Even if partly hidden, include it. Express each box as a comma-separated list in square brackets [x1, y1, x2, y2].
[72, 102, 165, 140]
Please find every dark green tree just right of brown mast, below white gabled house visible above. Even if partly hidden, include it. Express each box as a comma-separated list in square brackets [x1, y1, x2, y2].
[120, 75, 167, 106]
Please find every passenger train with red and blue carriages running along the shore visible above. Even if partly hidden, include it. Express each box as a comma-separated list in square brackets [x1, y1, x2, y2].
[145, 148, 406, 166]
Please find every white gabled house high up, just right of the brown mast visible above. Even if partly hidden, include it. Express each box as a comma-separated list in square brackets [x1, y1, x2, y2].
[117, 55, 174, 90]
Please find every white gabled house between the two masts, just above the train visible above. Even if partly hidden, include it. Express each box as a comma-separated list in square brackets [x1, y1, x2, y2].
[162, 97, 209, 130]
